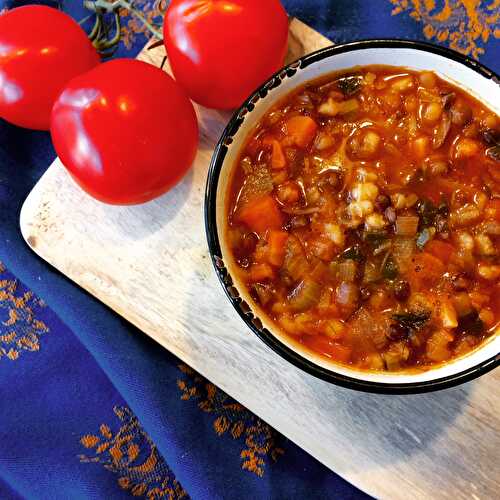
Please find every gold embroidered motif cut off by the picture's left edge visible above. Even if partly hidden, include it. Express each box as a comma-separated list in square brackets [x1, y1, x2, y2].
[0, 263, 49, 362]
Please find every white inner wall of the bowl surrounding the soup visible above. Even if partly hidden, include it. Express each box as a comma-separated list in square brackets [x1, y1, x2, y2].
[216, 48, 500, 384]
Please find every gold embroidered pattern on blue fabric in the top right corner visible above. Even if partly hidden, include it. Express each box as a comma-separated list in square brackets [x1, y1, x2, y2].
[390, 0, 500, 59]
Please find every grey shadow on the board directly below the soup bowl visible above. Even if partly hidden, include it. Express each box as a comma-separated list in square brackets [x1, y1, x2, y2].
[304, 377, 473, 467]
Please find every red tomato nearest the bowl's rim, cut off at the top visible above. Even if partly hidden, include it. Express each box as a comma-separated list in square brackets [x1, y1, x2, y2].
[163, 0, 288, 109]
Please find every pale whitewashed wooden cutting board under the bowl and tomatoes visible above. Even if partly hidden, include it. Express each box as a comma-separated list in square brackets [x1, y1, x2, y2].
[17, 20, 500, 499]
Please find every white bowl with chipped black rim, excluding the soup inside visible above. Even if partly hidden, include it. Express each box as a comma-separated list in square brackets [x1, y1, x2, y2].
[205, 40, 500, 393]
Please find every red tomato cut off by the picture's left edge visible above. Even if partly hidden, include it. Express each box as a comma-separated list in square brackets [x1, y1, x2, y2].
[0, 5, 100, 130]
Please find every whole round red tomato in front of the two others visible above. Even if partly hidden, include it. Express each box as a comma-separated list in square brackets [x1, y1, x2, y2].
[51, 59, 198, 205]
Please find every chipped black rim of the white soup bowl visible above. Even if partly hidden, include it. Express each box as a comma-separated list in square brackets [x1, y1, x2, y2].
[205, 39, 500, 394]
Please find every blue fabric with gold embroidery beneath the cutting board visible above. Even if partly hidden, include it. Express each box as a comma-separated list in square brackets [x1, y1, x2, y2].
[0, 0, 500, 499]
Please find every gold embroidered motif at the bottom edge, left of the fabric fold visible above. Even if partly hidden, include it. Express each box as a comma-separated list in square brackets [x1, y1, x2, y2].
[78, 406, 188, 500]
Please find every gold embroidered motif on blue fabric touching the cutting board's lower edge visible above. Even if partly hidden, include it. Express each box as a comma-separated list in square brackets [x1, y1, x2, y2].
[177, 364, 284, 477]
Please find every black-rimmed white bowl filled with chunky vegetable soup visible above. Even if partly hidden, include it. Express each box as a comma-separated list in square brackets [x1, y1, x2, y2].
[205, 40, 500, 393]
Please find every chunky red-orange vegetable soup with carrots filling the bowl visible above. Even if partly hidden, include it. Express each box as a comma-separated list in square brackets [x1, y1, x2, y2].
[227, 66, 500, 371]
